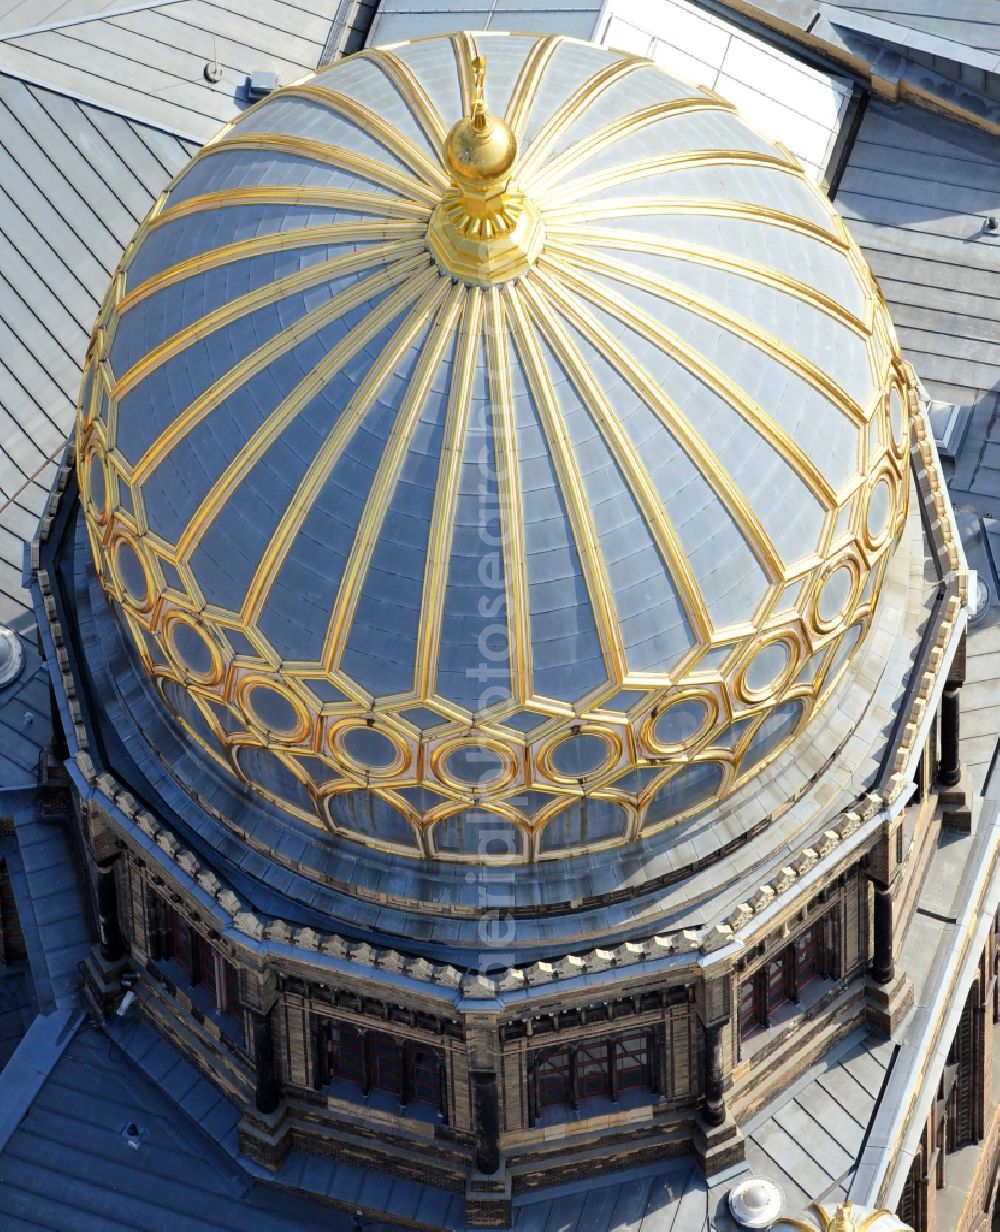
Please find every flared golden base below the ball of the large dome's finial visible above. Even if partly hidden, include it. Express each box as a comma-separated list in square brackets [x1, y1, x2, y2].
[427, 188, 546, 287]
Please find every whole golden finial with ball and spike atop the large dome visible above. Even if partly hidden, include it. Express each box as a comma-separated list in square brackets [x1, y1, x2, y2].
[429, 55, 543, 286]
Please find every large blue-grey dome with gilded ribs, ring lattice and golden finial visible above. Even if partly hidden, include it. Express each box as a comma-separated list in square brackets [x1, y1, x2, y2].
[78, 24, 911, 860]
